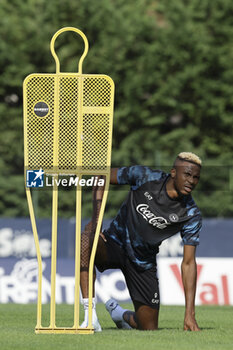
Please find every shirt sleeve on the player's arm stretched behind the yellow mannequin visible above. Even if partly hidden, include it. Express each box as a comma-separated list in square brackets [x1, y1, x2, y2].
[117, 165, 163, 187]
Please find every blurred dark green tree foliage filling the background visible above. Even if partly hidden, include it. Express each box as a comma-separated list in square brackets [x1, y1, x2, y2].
[0, 0, 233, 217]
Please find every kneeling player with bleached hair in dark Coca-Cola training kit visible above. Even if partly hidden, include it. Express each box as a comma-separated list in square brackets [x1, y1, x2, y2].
[81, 152, 201, 331]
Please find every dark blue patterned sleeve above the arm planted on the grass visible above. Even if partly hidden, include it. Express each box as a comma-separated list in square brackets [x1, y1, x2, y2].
[180, 215, 202, 246]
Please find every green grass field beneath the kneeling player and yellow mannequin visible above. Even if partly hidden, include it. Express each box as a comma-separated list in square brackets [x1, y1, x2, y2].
[0, 304, 233, 350]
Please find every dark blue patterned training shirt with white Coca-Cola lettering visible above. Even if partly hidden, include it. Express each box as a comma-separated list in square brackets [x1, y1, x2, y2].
[105, 165, 202, 270]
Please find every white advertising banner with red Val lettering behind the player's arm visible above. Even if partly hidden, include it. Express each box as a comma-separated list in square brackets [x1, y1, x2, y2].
[158, 258, 233, 305]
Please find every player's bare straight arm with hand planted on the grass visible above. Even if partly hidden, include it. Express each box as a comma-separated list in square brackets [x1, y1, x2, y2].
[181, 245, 200, 331]
